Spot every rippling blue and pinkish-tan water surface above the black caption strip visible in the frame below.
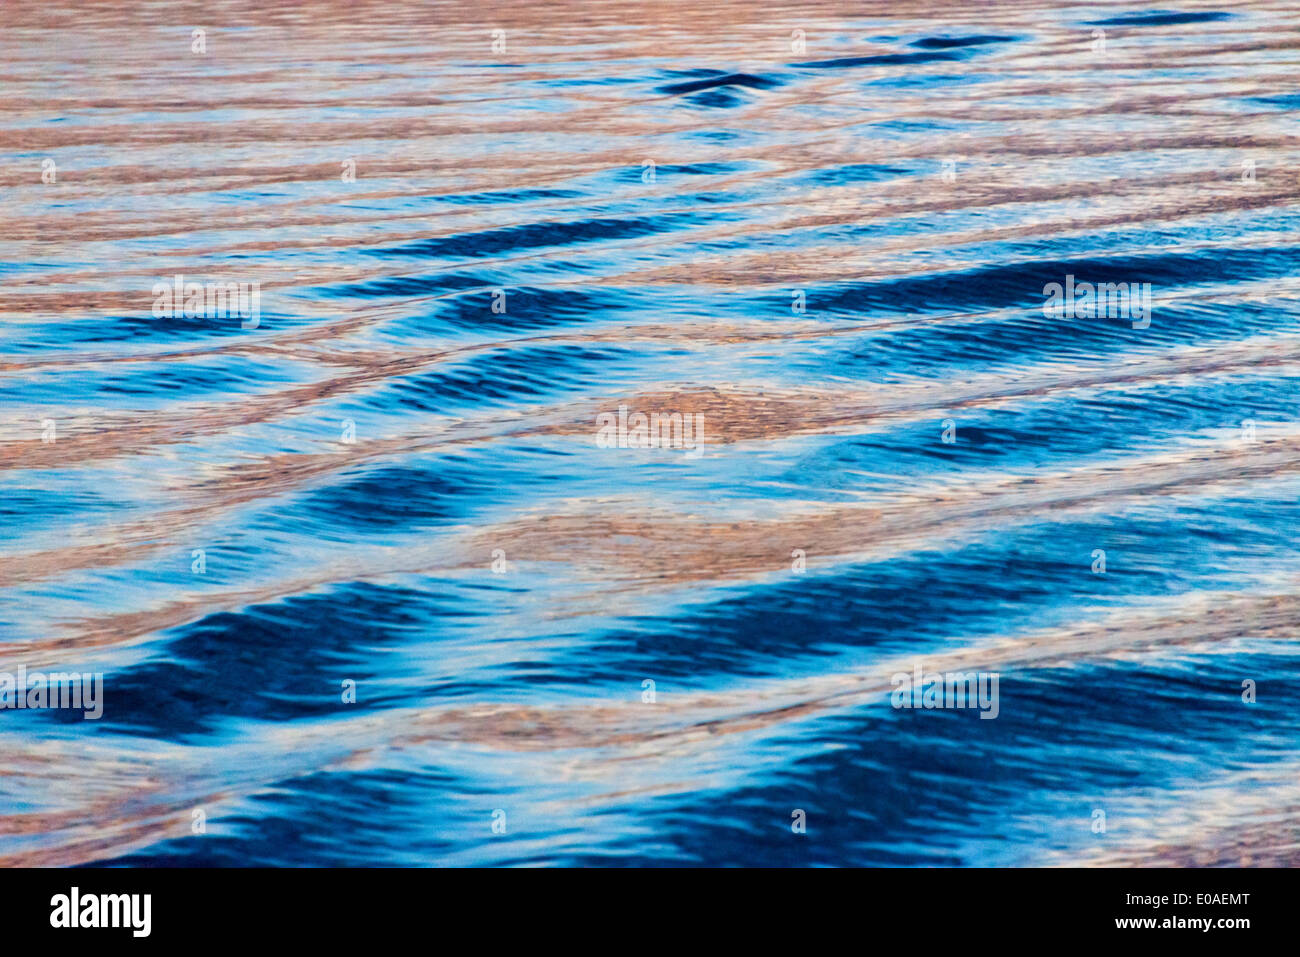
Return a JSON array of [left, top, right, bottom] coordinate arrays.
[[0, 0, 1300, 865]]
